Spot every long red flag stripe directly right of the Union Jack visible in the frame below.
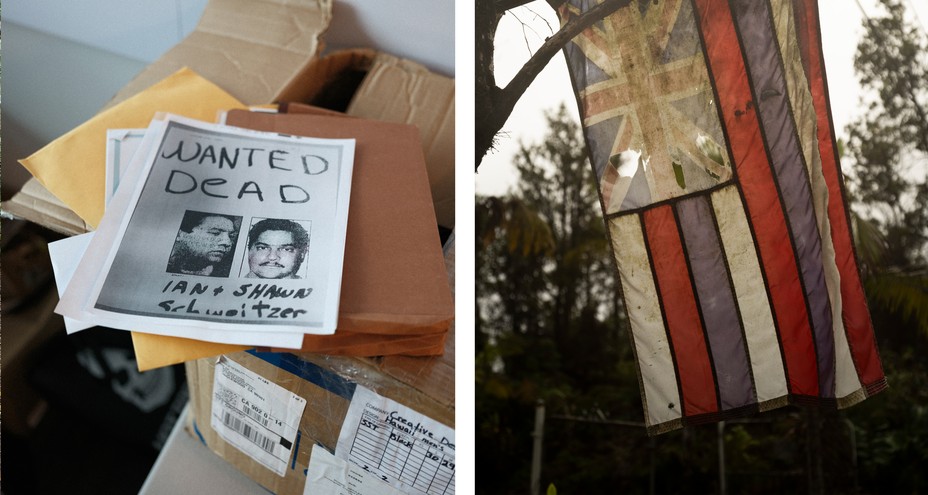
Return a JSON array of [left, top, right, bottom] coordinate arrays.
[[694, 0, 819, 396]]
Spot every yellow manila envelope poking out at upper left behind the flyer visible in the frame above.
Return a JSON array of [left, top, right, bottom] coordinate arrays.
[[19, 67, 245, 228]]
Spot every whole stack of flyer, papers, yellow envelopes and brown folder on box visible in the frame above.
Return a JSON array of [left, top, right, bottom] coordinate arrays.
[[23, 70, 453, 369]]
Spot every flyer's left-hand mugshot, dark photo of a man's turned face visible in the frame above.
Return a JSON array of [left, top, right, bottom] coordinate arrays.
[[166, 210, 242, 277]]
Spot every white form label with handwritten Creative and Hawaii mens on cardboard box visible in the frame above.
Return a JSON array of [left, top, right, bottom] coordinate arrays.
[[335, 386, 454, 495]]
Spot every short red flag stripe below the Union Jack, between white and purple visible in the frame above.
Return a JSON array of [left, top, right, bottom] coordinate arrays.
[[643, 205, 718, 416]]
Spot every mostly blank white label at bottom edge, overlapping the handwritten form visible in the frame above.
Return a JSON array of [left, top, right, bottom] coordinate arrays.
[[303, 444, 406, 495]]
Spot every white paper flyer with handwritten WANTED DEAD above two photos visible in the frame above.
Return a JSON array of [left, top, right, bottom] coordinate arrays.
[[57, 116, 354, 340]]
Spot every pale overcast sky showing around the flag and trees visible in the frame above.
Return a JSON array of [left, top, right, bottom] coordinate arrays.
[[475, 0, 928, 195]]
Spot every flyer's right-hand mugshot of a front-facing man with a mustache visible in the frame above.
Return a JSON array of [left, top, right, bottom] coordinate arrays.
[[240, 218, 312, 279]]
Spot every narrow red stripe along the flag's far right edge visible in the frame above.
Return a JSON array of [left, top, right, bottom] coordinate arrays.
[[800, 0, 884, 392]]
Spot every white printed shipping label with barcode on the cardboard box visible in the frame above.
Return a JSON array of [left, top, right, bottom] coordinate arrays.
[[210, 356, 306, 476]]
